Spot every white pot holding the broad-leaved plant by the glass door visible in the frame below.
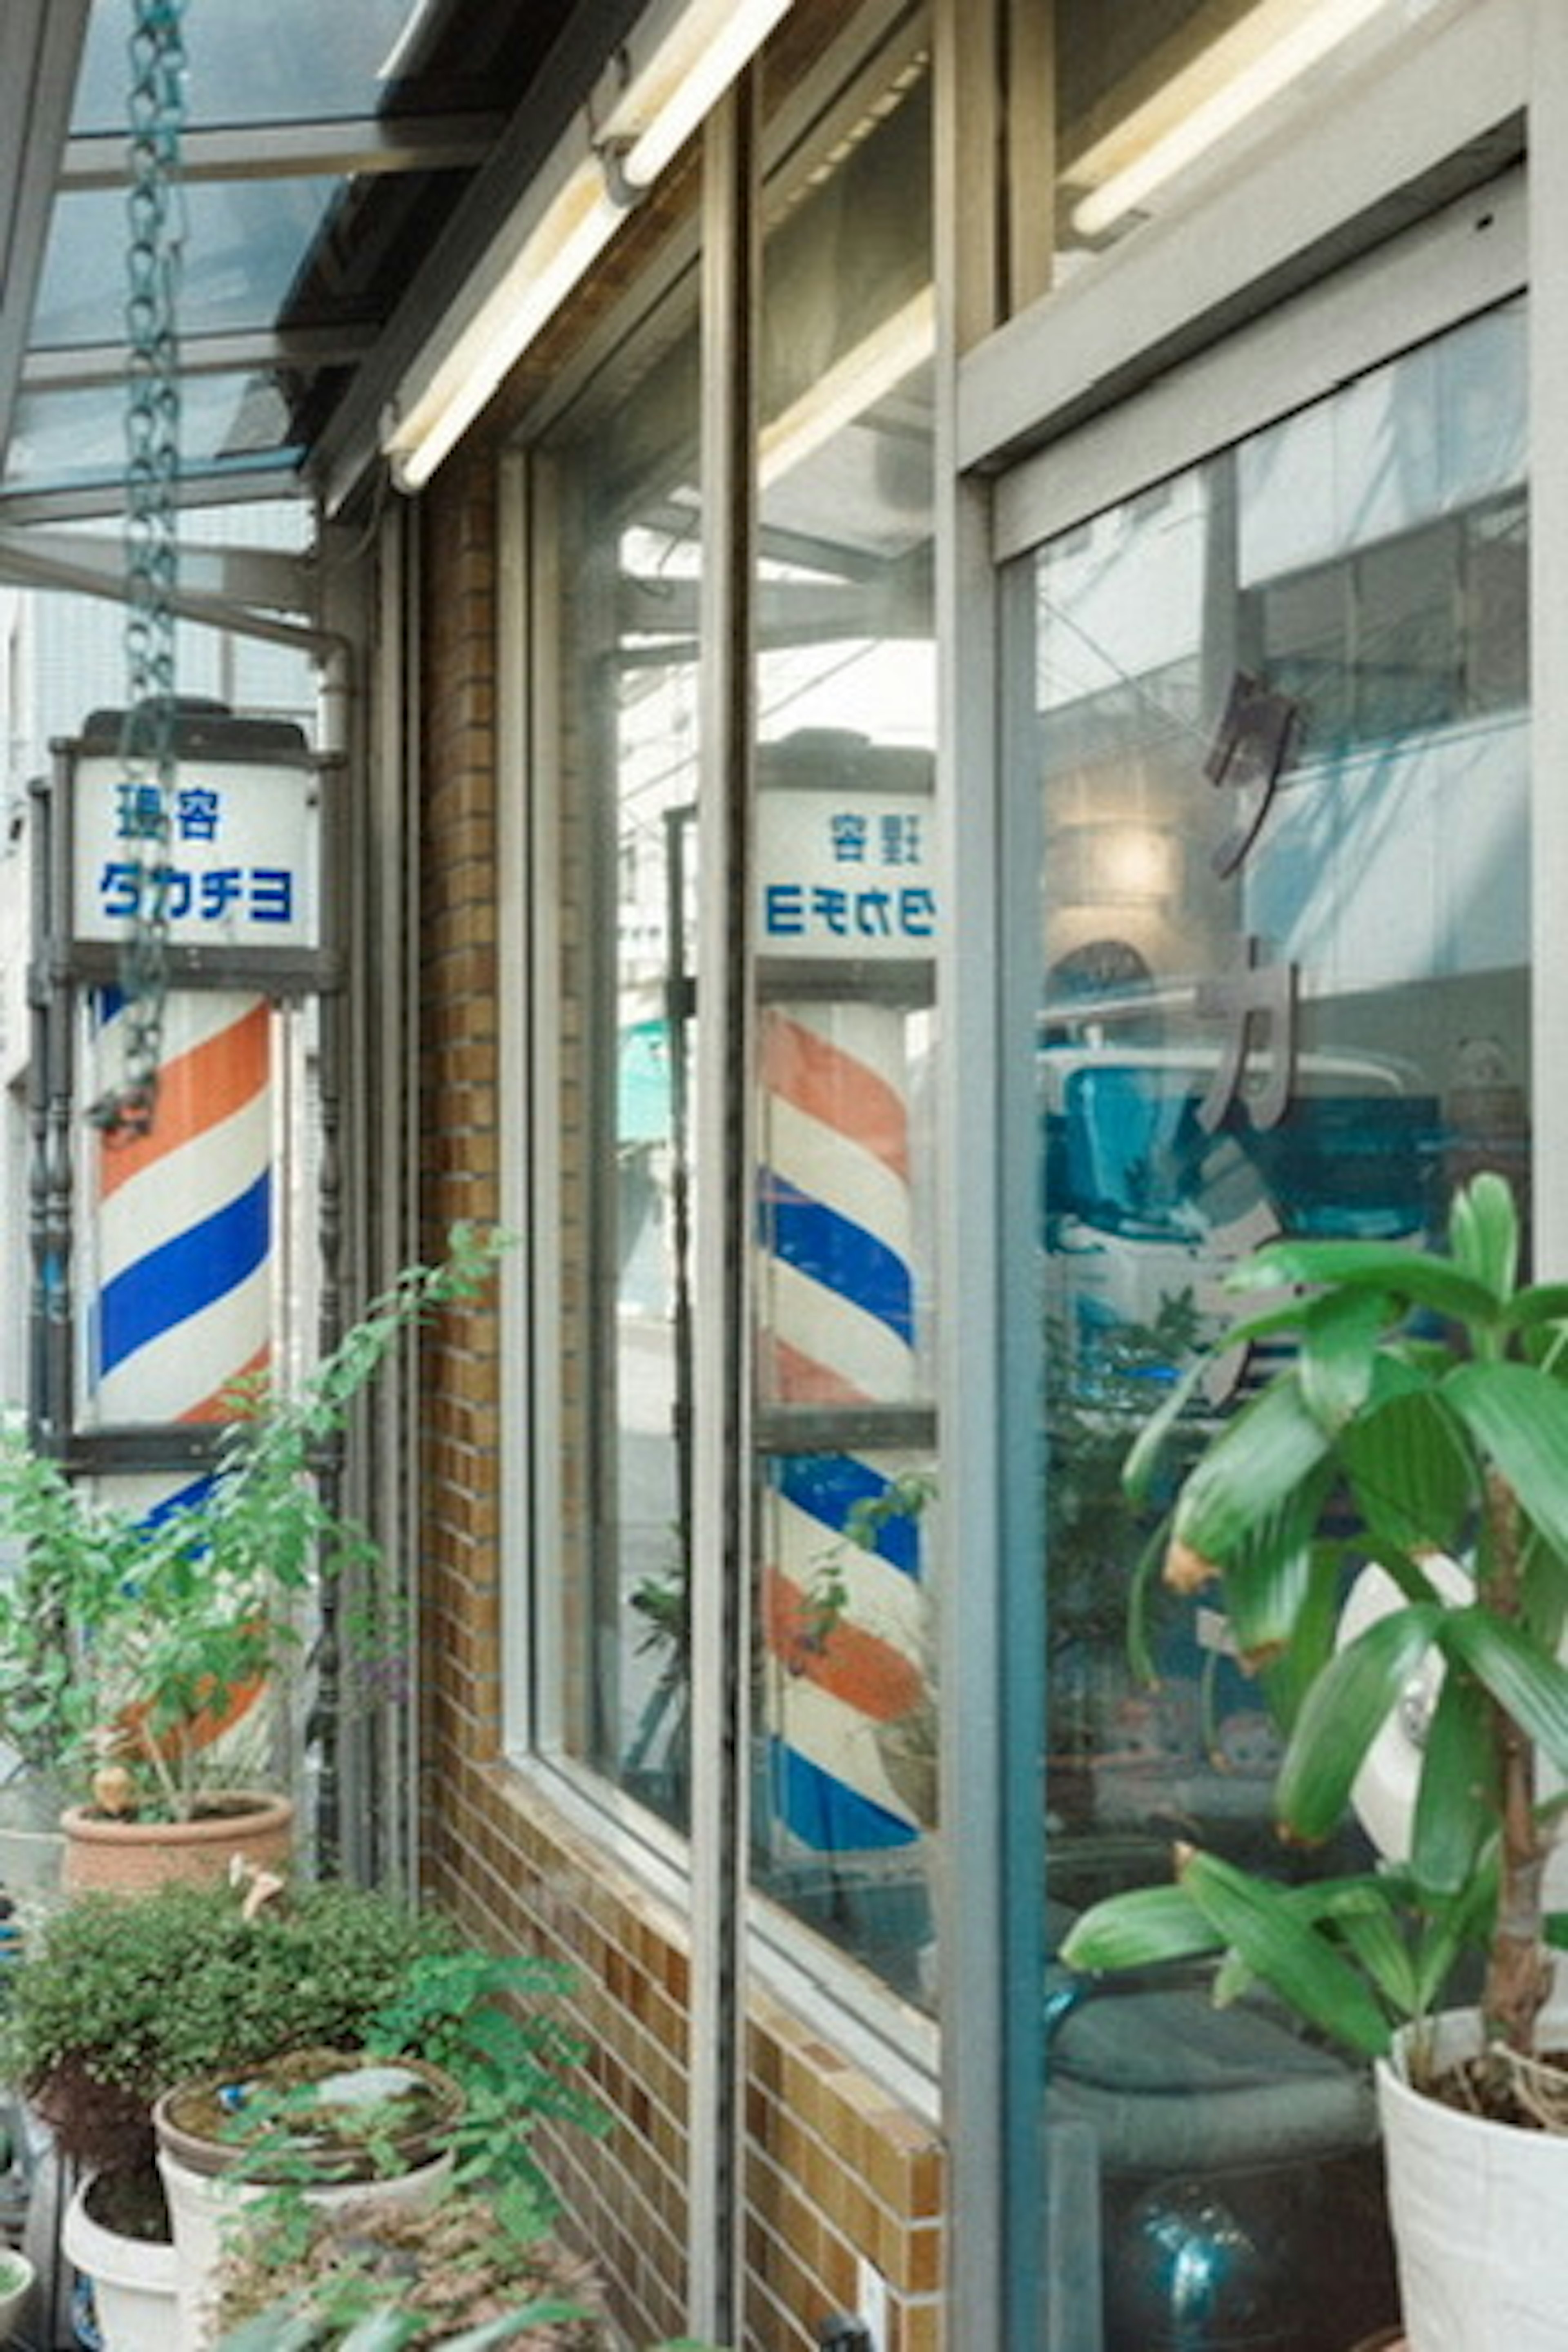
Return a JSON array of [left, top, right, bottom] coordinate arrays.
[[1378, 2011, 1568, 2352]]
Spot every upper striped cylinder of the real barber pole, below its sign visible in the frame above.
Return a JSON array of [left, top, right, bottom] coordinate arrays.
[[89, 990, 273, 1423]]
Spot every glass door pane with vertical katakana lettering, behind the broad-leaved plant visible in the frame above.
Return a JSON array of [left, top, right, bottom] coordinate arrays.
[[1013, 303, 1530, 2352]]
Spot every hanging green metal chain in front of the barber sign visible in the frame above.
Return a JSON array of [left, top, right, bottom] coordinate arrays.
[[89, 0, 186, 1136]]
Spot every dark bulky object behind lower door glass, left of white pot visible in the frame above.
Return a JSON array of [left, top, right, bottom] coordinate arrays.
[[1046, 1903, 1399, 2352]]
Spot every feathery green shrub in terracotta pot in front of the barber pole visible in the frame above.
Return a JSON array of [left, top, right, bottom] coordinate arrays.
[[0, 1225, 501, 1889]]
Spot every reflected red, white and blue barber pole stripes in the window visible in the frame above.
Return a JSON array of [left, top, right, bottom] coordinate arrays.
[[760, 1002, 922, 1851]]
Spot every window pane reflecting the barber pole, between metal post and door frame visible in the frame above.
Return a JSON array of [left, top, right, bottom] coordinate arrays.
[[752, 61, 940, 1997]]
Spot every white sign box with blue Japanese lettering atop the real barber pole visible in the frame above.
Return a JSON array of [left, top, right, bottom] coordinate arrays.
[[73, 757, 320, 948]]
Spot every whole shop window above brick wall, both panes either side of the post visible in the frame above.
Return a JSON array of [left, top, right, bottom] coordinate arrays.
[[536, 13, 940, 1997]]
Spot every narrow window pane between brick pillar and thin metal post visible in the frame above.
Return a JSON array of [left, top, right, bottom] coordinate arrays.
[[538, 275, 701, 1823]]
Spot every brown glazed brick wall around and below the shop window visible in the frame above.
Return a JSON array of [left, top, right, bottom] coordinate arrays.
[[421, 442, 943, 2352]]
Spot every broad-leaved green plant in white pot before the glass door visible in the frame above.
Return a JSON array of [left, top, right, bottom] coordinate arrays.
[[1062, 1174, 1568, 2352]]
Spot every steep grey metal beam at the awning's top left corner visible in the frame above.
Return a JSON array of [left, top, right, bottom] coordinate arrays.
[[0, 0, 89, 452]]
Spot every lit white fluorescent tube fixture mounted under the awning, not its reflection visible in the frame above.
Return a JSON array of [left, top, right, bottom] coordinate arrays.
[[381, 0, 792, 492]]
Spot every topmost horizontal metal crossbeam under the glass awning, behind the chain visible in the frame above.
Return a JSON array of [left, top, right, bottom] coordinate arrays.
[[59, 115, 506, 193]]
